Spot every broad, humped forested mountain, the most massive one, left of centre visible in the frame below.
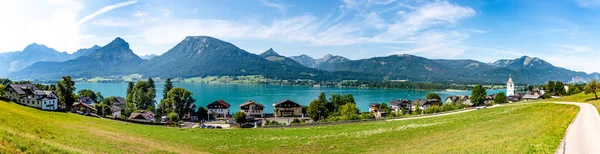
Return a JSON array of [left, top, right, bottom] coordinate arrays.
[[137, 36, 383, 80]]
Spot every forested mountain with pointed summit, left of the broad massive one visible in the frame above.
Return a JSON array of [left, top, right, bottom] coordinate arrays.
[[9, 37, 144, 80]]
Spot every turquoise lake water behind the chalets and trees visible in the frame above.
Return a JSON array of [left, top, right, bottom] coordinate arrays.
[[75, 83, 505, 113]]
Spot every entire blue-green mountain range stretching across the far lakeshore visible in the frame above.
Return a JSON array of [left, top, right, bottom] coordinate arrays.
[[3, 36, 599, 84]]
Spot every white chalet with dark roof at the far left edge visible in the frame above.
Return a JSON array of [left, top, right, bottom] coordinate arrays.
[[5, 84, 58, 110]]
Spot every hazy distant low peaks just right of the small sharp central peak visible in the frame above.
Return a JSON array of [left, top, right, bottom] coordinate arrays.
[[289, 54, 350, 70]]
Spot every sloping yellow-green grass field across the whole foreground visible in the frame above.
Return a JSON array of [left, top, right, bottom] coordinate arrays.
[[0, 101, 579, 153]]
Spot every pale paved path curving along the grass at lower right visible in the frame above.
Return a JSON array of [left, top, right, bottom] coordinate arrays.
[[556, 102, 600, 154]]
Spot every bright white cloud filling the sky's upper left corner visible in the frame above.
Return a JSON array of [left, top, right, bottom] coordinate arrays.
[[0, 0, 138, 52]]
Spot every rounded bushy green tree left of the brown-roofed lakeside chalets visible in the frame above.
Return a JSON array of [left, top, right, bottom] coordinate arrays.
[[163, 88, 196, 119]]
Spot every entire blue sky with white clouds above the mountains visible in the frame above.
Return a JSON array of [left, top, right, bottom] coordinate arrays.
[[0, 0, 600, 73]]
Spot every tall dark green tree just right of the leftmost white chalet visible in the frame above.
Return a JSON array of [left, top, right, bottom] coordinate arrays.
[[56, 76, 75, 109]]
